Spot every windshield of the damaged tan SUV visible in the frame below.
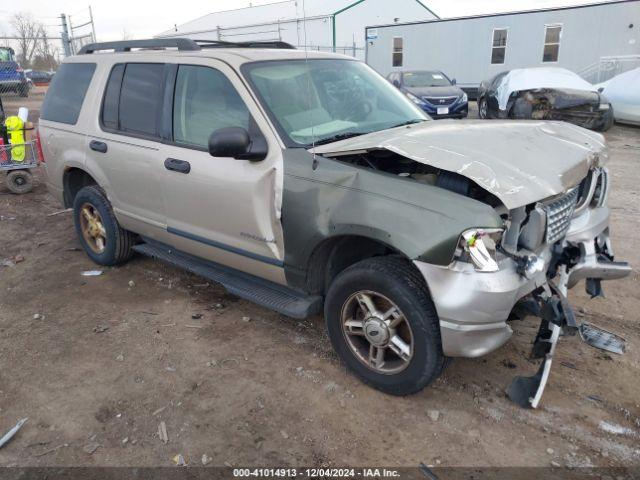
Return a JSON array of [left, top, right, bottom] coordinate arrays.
[[243, 59, 429, 147]]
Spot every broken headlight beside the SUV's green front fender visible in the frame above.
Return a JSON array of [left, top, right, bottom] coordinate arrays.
[[456, 228, 504, 272]]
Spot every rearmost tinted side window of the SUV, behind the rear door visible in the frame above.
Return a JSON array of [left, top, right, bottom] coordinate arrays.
[[40, 63, 96, 125]]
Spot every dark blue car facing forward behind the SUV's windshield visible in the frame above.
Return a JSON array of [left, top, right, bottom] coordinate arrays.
[[387, 70, 469, 119]]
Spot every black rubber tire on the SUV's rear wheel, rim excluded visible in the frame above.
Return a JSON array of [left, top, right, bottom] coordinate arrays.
[[73, 185, 136, 266]]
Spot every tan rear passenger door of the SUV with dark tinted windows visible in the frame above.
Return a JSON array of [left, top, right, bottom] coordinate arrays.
[[86, 62, 169, 239]]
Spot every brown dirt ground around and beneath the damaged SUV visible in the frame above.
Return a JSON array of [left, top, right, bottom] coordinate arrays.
[[0, 91, 640, 466]]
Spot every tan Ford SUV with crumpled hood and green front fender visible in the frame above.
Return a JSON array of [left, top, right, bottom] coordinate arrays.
[[39, 39, 629, 407]]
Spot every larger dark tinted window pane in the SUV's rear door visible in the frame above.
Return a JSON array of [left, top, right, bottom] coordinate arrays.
[[119, 63, 164, 137]]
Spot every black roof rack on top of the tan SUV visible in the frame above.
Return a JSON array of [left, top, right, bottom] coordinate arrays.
[[78, 38, 296, 55]]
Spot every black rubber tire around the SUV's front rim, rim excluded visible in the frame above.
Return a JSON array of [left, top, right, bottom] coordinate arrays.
[[325, 256, 445, 395]]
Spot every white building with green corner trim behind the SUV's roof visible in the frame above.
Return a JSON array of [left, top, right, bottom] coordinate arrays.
[[157, 0, 438, 59]]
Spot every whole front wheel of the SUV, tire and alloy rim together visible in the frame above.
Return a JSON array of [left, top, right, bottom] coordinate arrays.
[[325, 256, 445, 395]]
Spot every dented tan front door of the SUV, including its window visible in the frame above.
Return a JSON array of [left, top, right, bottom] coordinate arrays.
[[162, 59, 286, 284]]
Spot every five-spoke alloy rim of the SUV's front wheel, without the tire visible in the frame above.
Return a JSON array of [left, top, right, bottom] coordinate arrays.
[[340, 290, 414, 375]]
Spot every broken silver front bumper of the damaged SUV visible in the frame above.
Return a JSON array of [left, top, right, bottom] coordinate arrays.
[[414, 207, 631, 357]]
